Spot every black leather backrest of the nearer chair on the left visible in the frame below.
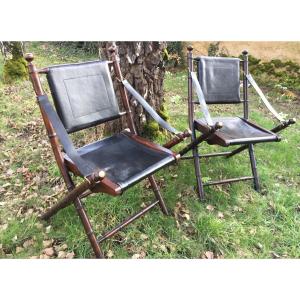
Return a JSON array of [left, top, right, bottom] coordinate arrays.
[[47, 61, 120, 132]]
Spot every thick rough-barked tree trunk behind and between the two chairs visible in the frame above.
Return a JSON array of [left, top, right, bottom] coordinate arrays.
[[100, 42, 167, 135]]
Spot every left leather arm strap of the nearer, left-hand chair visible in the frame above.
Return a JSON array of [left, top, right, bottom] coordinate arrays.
[[37, 95, 99, 177]]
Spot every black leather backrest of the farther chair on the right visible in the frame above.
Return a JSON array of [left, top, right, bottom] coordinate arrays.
[[196, 56, 241, 104]]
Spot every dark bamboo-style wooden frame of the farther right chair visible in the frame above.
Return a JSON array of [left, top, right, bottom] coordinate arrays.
[[182, 46, 296, 200]]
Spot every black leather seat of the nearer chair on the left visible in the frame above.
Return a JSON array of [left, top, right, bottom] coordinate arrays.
[[65, 132, 176, 190]]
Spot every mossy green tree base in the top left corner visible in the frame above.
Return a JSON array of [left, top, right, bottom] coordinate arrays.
[[1, 42, 27, 82]]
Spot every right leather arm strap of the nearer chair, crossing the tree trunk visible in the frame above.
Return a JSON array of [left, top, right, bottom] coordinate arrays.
[[122, 80, 179, 134]]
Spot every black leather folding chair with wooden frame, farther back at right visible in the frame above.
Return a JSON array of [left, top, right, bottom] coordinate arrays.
[[185, 47, 295, 200]]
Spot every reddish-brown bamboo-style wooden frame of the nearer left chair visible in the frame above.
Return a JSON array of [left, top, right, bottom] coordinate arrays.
[[25, 47, 190, 258]]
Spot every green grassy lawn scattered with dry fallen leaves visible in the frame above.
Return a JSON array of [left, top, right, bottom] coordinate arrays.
[[0, 43, 300, 258]]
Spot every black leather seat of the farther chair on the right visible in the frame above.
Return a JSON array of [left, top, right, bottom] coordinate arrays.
[[194, 117, 280, 147]]
